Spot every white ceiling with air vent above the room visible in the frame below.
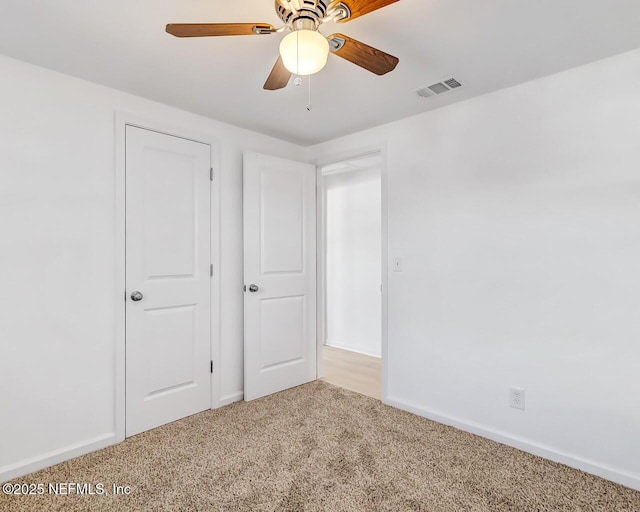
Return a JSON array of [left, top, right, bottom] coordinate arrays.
[[0, 0, 640, 145]]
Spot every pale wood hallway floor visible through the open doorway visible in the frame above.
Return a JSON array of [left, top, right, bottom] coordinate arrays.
[[321, 345, 382, 400]]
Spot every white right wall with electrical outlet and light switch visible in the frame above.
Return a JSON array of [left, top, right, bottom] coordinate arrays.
[[308, 50, 640, 489]]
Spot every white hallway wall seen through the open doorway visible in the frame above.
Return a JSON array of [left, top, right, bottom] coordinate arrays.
[[323, 167, 382, 357]]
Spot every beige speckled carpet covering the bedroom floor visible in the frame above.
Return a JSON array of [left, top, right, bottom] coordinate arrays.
[[0, 382, 640, 512]]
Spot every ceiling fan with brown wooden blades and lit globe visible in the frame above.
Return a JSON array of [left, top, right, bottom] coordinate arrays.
[[167, 0, 399, 91]]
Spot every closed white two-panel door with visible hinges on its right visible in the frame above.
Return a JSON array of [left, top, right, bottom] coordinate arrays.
[[125, 126, 211, 436]]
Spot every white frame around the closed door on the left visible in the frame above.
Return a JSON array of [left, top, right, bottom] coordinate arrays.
[[114, 111, 220, 443]]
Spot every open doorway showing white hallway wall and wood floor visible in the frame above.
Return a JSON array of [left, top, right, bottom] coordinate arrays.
[[318, 152, 383, 399]]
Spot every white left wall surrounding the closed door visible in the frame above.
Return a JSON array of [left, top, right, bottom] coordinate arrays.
[[0, 57, 303, 480]]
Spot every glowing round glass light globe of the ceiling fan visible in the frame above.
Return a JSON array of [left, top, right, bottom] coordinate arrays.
[[280, 30, 329, 75]]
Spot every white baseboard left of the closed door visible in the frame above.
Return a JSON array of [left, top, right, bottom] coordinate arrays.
[[0, 432, 119, 482]]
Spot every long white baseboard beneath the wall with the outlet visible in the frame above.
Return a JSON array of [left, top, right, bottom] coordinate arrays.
[[385, 397, 640, 491]]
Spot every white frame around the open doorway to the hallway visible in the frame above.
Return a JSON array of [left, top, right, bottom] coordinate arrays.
[[313, 143, 389, 403]]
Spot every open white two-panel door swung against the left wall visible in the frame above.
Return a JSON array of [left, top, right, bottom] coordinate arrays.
[[244, 152, 316, 400]]
